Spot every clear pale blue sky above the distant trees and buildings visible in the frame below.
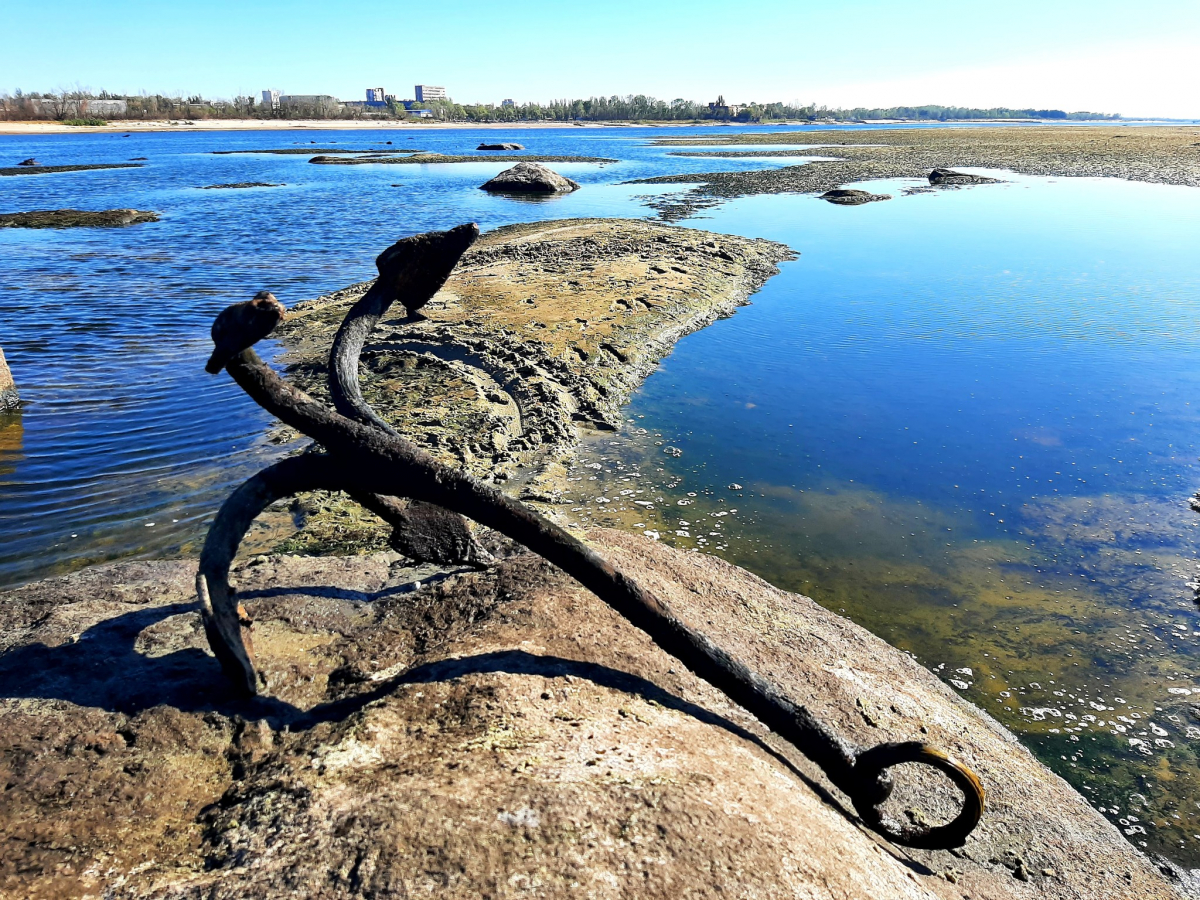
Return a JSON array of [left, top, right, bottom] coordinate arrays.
[[0, 0, 1200, 116]]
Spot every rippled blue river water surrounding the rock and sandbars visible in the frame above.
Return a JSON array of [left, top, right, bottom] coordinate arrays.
[[0, 128, 1200, 865]]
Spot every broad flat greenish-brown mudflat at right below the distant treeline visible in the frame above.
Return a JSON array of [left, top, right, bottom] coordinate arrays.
[[634, 125, 1200, 220]]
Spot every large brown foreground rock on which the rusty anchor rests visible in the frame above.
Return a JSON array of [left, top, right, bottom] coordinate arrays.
[[0, 532, 1177, 900]]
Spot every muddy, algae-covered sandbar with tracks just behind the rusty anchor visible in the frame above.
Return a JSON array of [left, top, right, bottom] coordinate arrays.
[[276, 220, 794, 552]]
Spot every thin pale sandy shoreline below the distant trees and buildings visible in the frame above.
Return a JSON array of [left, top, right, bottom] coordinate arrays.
[[0, 119, 1188, 134]]
